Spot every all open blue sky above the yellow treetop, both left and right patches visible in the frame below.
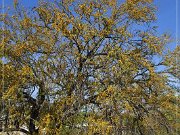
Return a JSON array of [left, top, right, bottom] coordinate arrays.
[[0, 0, 180, 50]]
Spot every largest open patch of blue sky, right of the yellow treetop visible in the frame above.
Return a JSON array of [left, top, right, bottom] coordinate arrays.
[[154, 0, 180, 50]]
